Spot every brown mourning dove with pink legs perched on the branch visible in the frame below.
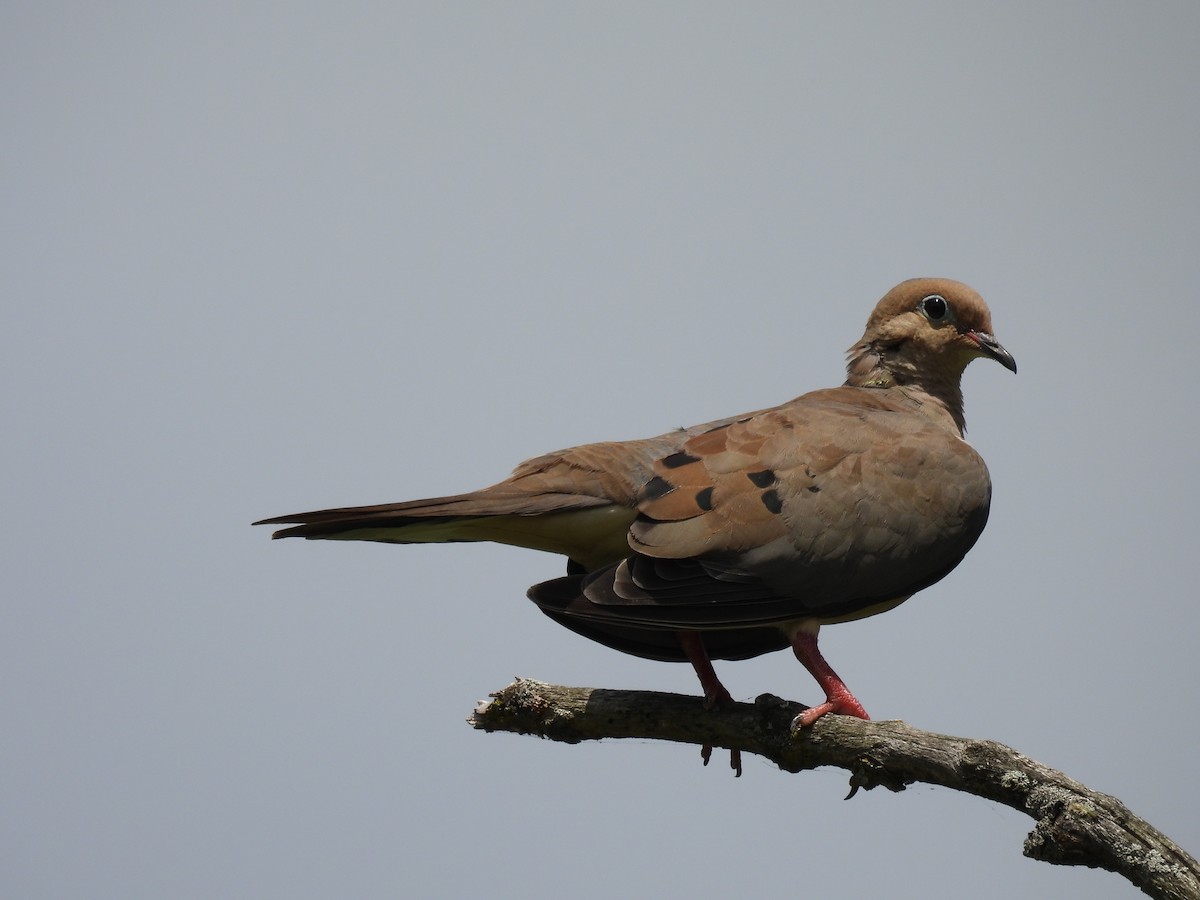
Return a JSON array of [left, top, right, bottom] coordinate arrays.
[[256, 278, 1016, 758]]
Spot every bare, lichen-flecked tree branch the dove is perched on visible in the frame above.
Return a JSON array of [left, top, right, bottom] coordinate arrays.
[[468, 678, 1200, 900]]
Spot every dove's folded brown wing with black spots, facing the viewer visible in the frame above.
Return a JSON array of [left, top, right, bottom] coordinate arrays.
[[534, 388, 991, 629]]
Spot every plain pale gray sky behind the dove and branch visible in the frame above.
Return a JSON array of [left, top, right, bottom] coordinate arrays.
[[0, 2, 1200, 900]]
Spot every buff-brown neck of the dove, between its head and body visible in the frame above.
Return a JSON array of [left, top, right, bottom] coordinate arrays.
[[846, 342, 967, 436]]
